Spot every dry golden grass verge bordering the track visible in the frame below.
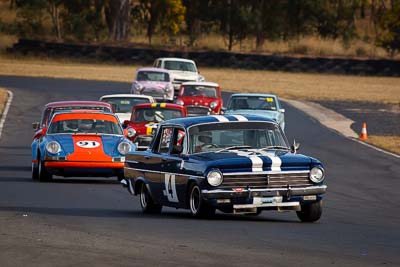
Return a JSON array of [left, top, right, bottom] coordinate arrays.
[[0, 55, 400, 155]]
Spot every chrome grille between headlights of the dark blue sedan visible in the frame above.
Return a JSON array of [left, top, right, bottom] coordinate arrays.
[[219, 172, 313, 189]]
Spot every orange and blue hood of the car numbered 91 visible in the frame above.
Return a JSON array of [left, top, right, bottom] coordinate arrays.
[[46, 134, 125, 156]]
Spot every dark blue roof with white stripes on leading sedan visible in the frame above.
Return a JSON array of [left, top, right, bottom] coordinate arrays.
[[161, 114, 276, 128]]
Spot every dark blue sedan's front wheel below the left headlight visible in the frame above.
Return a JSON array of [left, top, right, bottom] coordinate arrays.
[[188, 184, 215, 218]]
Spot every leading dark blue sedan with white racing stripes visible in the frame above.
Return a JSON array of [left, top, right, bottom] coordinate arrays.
[[121, 115, 327, 222]]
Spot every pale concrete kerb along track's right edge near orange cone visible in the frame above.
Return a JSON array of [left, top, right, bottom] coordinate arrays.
[[281, 98, 400, 158]]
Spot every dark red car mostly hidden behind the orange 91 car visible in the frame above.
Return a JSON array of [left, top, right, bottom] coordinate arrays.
[[32, 101, 113, 139]]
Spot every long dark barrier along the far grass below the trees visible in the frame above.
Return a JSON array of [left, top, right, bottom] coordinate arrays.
[[8, 39, 400, 77]]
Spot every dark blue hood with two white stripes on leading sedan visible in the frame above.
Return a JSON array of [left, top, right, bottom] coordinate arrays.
[[191, 149, 319, 173]]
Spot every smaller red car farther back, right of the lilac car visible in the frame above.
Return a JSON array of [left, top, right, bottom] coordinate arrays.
[[175, 82, 223, 116]]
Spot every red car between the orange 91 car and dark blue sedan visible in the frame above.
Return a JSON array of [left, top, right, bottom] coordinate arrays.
[[123, 103, 187, 150]]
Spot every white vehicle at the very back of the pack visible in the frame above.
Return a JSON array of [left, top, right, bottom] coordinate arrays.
[[153, 57, 205, 96]]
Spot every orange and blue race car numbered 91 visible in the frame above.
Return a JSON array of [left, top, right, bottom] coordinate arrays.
[[32, 110, 135, 181]]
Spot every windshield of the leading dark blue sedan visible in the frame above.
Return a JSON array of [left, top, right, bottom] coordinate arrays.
[[189, 122, 288, 154]]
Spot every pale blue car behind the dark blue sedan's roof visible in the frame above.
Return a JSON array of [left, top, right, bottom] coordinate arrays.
[[225, 94, 285, 130]]
